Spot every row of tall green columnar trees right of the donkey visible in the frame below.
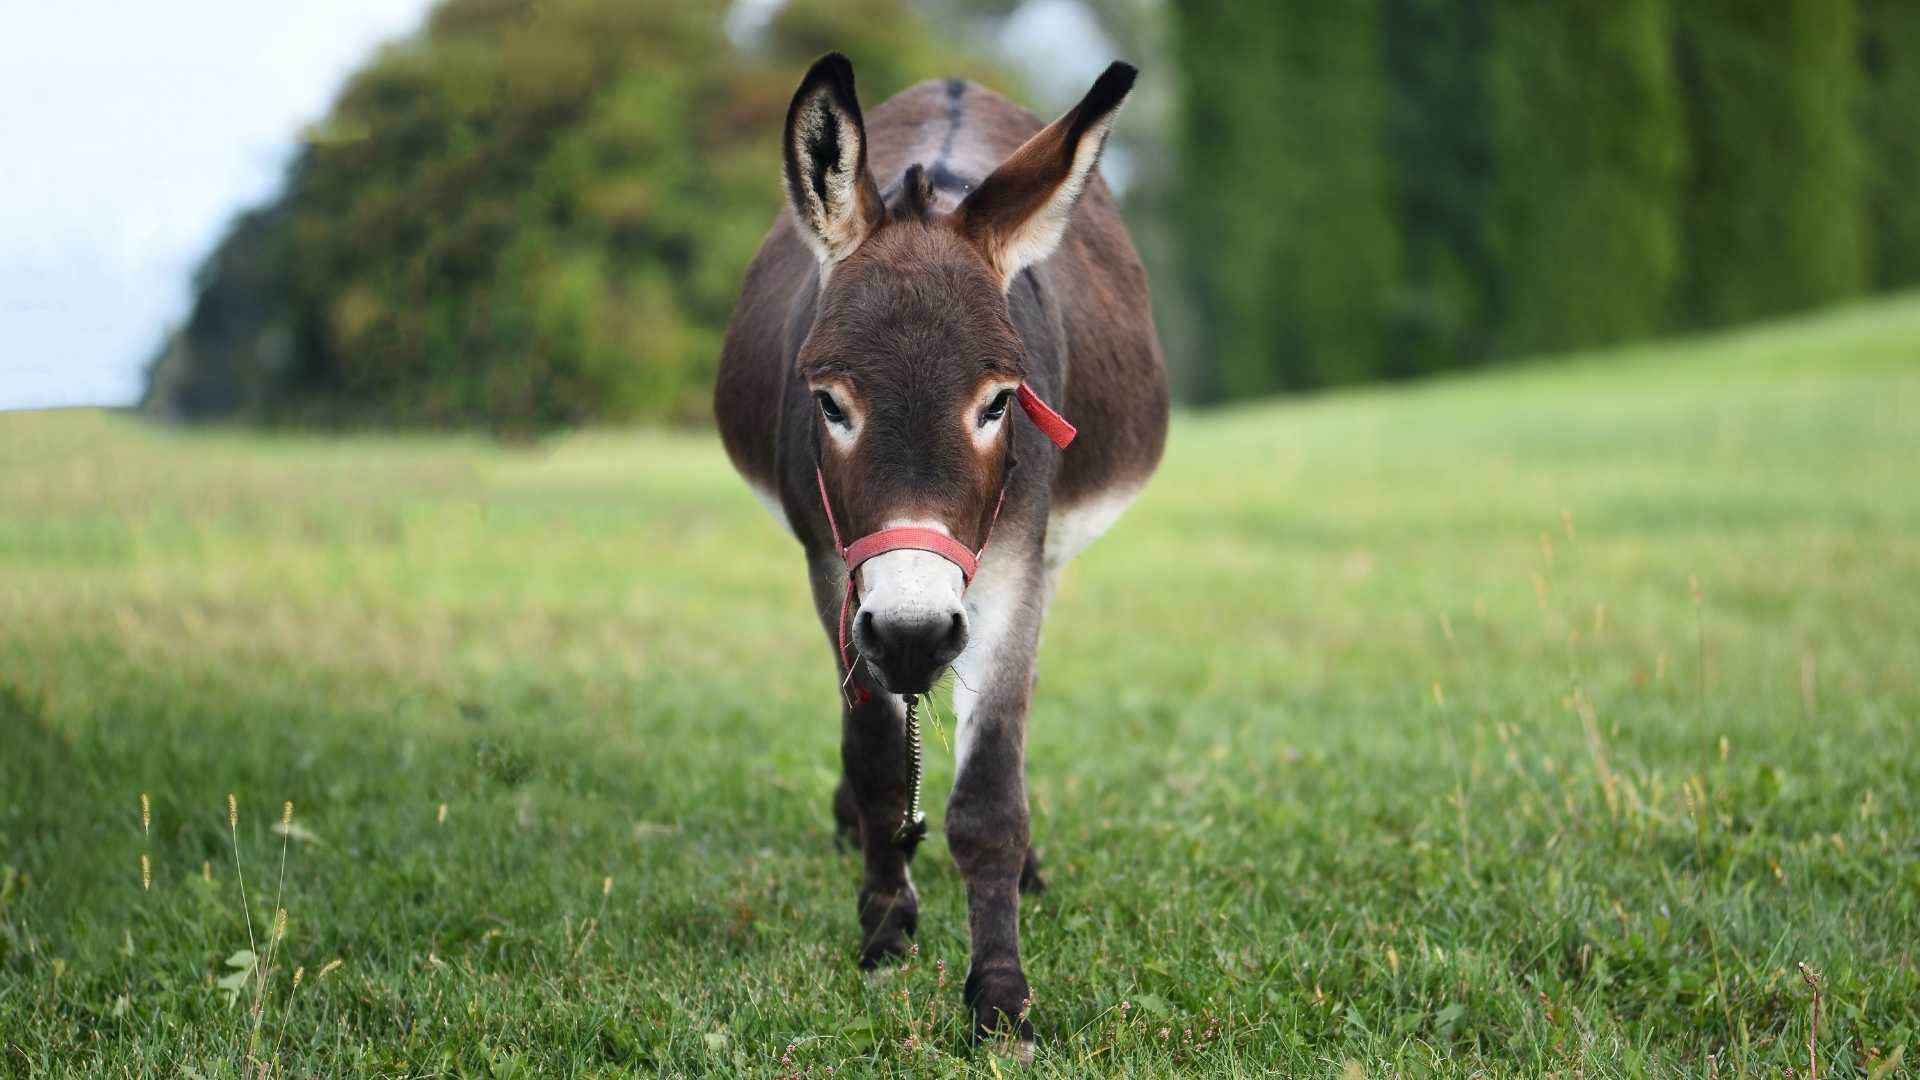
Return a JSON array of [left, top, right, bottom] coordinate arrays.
[[1173, 0, 1920, 398]]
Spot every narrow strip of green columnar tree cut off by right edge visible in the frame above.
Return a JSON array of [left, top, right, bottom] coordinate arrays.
[[1860, 0, 1920, 288]]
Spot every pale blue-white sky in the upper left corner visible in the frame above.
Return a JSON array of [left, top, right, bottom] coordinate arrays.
[[0, 0, 428, 409]]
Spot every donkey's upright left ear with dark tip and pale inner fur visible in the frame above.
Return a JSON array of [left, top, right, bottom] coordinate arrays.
[[781, 52, 887, 265]]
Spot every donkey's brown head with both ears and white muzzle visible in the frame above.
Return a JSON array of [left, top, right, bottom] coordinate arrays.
[[783, 54, 1135, 694]]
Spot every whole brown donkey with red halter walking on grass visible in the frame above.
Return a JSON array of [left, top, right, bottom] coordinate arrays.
[[714, 54, 1167, 1051]]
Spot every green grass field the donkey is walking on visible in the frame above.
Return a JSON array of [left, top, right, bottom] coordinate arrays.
[[0, 298, 1920, 1076]]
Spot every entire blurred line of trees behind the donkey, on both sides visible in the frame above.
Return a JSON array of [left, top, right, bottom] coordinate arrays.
[[148, 0, 1920, 430]]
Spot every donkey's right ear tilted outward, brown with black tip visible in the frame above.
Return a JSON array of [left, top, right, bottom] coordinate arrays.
[[958, 61, 1139, 288]]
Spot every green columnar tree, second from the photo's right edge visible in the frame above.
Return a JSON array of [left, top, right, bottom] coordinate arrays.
[[1674, 0, 1858, 325]]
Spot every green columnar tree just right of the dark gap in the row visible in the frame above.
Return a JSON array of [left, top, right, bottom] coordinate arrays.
[[1486, 0, 1684, 354]]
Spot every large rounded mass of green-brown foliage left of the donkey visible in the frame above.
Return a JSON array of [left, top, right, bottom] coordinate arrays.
[[152, 0, 990, 429]]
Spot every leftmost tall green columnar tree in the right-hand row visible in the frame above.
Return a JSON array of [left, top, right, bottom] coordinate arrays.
[[1175, 0, 1400, 398]]
